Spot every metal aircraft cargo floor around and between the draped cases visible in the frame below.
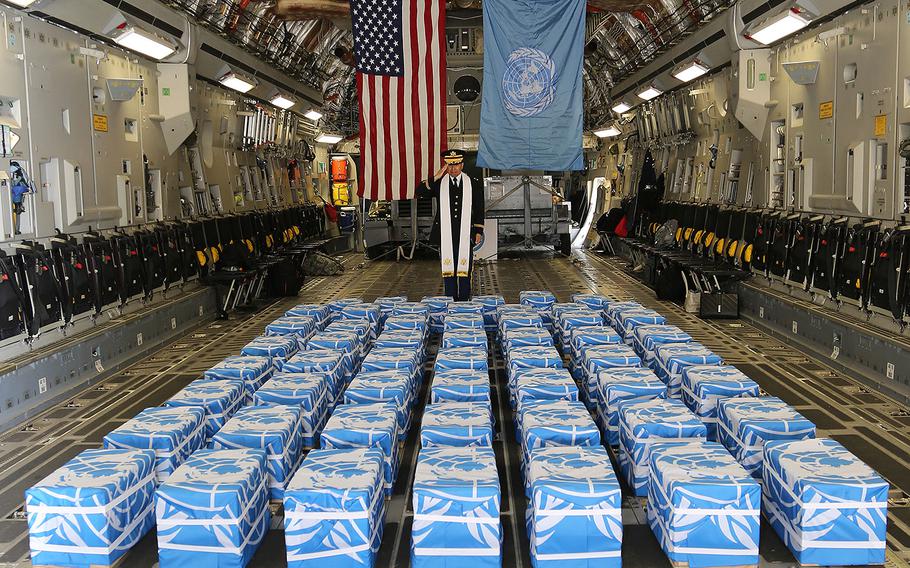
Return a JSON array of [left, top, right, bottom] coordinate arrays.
[[0, 255, 910, 568]]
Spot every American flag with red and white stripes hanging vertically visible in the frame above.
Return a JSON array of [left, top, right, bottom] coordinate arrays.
[[351, 0, 446, 200]]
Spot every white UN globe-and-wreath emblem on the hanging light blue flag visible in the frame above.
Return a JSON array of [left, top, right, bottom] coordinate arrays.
[[502, 47, 556, 116]]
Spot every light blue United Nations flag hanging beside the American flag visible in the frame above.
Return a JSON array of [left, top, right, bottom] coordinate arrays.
[[477, 0, 585, 170]]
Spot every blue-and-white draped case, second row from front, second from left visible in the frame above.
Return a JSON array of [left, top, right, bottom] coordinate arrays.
[[211, 406, 303, 499]]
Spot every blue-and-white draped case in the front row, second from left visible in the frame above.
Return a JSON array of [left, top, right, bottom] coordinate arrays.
[[155, 450, 271, 568]]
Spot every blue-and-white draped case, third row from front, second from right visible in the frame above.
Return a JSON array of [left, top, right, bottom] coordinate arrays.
[[597, 367, 667, 446]]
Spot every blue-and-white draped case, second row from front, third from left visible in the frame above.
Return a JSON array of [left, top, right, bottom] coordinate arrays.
[[321, 404, 398, 494]]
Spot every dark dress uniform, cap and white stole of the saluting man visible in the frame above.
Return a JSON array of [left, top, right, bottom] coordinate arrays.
[[417, 150, 484, 301]]
